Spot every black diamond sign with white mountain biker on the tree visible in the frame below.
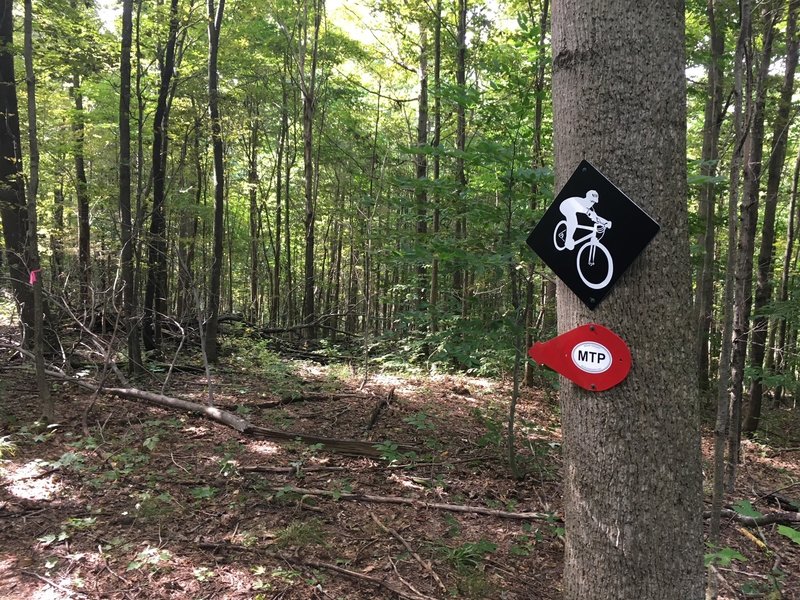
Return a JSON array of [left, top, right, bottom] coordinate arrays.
[[528, 160, 659, 310]]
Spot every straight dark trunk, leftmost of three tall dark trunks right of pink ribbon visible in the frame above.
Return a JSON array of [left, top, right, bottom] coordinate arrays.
[[119, 0, 142, 374]]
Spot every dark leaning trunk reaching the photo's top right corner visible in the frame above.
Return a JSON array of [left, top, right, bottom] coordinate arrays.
[[742, 0, 800, 433]]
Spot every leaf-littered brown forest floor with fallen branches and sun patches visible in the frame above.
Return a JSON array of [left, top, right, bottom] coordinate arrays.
[[0, 330, 800, 600]]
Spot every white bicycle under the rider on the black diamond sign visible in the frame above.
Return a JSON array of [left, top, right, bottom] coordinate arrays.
[[553, 217, 614, 290]]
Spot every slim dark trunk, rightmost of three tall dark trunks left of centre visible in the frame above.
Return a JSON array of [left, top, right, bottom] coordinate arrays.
[[205, 0, 225, 363]]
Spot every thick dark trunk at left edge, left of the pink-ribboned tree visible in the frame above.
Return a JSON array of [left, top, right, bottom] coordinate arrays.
[[0, 0, 35, 338]]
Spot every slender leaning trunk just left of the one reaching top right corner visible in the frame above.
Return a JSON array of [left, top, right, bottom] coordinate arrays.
[[728, 7, 777, 478]]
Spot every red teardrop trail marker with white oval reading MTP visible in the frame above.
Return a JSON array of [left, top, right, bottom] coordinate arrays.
[[528, 323, 631, 392]]
